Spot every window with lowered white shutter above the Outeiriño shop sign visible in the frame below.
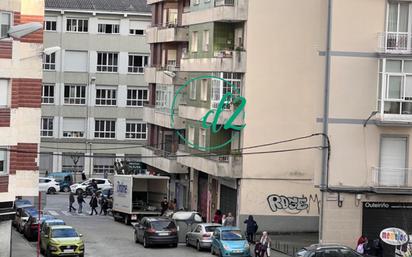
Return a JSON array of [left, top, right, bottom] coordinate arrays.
[[376, 136, 408, 187]]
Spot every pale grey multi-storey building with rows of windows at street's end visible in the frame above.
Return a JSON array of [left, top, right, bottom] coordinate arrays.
[[40, 0, 151, 177]]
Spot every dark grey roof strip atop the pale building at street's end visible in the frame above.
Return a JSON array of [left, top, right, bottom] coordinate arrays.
[[46, 0, 151, 13]]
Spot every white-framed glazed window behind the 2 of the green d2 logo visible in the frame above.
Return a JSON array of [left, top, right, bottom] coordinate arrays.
[[211, 72, 242, 109]]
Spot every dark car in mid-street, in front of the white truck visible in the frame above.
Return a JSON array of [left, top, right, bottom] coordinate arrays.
[[133, 217, 179, 248]]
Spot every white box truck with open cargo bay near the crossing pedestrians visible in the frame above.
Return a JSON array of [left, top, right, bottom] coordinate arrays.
[[112, 175, 169, 224]]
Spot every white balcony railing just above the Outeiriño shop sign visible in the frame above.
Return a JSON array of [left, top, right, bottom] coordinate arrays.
[[372, 167, 412, 188]]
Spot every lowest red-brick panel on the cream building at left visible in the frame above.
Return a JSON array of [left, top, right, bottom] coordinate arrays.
[[9, 143, 39, 174]]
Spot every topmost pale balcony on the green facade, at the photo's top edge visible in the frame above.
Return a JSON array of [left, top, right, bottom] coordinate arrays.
[[182, 0, 248, 26]]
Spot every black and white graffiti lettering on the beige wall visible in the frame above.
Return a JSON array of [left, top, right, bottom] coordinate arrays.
[[267, 194, 320, 214]]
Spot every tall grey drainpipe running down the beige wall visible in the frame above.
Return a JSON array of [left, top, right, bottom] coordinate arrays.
[[319, 0, 333, 243]]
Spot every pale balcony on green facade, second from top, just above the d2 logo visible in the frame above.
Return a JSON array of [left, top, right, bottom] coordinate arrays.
[[180, 50, 246, 73]]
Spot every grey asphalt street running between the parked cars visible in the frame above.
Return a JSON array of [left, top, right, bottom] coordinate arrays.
[[12, 193, 285, 257]]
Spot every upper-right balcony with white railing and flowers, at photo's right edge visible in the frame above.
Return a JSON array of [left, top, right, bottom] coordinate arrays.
[[378, 32, 412, 54]]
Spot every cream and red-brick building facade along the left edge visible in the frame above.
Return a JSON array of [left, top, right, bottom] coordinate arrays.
[[0, 0, 44, 254]]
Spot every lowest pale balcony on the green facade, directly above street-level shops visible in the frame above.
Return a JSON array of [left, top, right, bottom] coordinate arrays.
[[177, 145, 242, 178]]
